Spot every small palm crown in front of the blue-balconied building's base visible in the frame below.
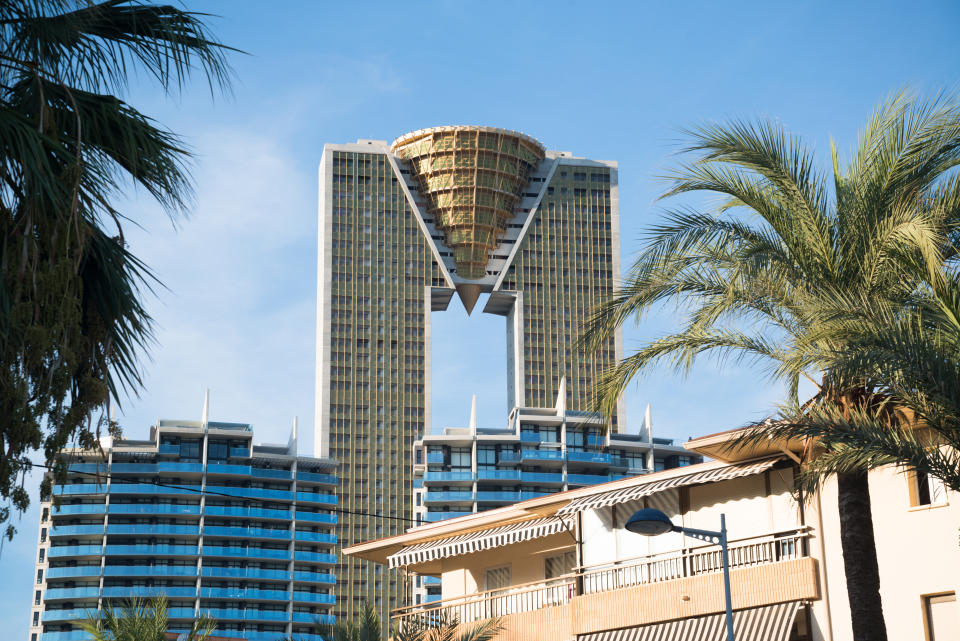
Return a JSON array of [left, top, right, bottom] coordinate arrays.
[[80, 596, 217, 641]]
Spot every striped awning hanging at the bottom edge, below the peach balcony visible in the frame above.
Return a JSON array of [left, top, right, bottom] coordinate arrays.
[[577, 601, 800, 641]]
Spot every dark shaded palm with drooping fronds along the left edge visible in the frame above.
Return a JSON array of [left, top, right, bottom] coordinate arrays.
[[0, 0, 229, 536]]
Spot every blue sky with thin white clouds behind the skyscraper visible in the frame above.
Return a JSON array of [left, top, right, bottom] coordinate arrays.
[[7, 0, 960, 639]]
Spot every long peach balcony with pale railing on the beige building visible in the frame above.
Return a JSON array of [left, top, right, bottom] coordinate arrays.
[[392, 529, 819, 641]]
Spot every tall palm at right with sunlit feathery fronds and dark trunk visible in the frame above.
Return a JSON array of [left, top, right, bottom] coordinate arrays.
[[581, 92, 960, 641]]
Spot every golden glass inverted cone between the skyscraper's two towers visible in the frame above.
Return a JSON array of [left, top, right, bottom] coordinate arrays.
[[391, 126, 545, 308]]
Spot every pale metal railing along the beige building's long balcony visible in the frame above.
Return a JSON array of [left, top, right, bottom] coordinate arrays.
[[393, 528, 809, 629]]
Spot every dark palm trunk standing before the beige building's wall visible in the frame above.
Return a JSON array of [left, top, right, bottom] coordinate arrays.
[[837, 472, 887, 641]]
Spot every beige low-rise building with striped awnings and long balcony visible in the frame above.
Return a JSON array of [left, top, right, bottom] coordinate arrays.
[[344, 424, 960, 641]]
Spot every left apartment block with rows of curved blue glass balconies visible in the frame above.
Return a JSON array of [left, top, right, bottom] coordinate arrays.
[[30, 420, 337, 641]]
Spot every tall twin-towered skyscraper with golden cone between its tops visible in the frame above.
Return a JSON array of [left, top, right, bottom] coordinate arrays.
[[315, 127, 623, 618]]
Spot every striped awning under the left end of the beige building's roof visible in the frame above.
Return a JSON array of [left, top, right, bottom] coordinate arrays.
[[387, 516, 567, 568]]
